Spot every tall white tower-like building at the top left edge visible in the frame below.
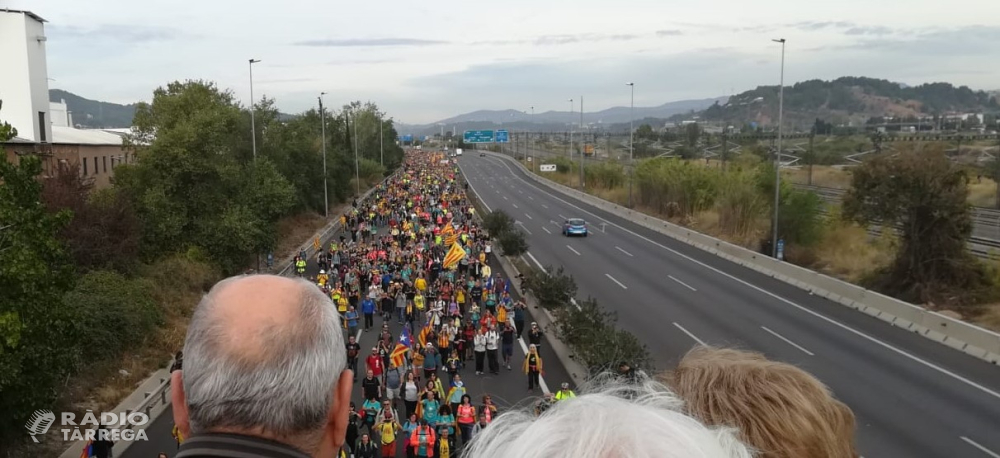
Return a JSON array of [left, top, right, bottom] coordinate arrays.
[[0, 9, 52, 143]]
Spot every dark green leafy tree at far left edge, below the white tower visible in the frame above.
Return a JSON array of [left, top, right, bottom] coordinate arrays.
[[0, 154, 76, 443]]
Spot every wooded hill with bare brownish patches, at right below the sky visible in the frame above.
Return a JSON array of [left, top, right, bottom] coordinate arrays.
[[696, 77, 1000, 129]]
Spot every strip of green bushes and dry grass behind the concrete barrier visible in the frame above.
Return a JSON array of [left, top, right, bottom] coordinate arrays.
[[535, 143, 1000, 330]]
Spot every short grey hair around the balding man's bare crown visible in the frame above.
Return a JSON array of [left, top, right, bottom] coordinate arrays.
[[183, 277, 347, 451]]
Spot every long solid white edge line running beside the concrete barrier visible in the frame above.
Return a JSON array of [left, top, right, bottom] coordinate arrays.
[[486, 156, 1000, 399]]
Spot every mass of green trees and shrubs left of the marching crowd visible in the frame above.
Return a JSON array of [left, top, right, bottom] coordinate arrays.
[[0, 81, 403, 457]]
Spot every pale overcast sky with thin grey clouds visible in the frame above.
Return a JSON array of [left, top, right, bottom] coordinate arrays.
[[0, 0, 1000, 124]]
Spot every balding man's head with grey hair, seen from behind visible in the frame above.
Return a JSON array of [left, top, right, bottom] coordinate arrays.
[[175, 275, 350, 454]]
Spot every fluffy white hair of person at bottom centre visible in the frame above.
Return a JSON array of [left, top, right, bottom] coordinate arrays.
[[463, 377, 753, 458]]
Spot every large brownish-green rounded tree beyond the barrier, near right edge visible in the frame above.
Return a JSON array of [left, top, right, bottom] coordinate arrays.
[[843, 150, 996, 305]]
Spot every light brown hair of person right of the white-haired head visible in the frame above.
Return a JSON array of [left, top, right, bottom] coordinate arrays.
[[662, 347, 858, 458]]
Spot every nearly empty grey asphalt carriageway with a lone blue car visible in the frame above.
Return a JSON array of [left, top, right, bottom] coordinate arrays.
[[459, 151, 1000, 458]]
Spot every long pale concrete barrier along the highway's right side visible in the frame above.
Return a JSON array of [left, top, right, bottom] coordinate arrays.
[[488, 153, 1000, 364]]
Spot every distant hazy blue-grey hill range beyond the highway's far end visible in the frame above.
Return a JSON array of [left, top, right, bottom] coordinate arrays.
[[399, 97, 728, 135]]
